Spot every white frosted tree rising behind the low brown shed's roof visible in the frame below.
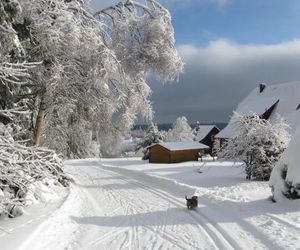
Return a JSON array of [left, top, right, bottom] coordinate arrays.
[[166, 116, 194, 142]]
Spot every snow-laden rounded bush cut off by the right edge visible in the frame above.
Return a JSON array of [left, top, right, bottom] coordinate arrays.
[[269, 126, 300, 201]]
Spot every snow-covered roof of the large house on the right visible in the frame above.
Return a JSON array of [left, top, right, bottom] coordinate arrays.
[[217, 81, 300, 138]]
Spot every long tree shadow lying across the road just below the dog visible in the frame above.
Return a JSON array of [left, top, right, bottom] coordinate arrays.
[[71, 204, 286, 249]]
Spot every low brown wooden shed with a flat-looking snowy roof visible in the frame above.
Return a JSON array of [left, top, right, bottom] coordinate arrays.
[[148, 142, 209, 163]]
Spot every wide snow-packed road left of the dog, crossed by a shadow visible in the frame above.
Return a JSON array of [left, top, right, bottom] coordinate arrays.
[[14, 161, 292, 250]]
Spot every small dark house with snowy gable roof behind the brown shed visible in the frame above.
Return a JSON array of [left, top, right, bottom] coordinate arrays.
[[195, 125, 220, 155]]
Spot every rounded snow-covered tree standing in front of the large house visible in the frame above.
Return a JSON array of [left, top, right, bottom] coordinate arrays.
[[218, 113, 289, 181]]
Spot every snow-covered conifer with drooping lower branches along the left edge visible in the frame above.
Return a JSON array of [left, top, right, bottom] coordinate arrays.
[[0, 0, 67, 217]]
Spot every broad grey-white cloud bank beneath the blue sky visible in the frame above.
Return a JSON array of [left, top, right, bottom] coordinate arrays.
[[153, 39, 300, 122]]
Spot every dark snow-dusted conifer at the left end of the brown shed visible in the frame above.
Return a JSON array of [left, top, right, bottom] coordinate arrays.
[[137, 123, 165, 160]]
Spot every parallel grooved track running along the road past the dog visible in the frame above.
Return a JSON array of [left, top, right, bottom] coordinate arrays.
[[98, 165, 241, 249]]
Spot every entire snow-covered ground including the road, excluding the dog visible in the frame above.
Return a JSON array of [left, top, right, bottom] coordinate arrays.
[[0, 159, 300, 250]]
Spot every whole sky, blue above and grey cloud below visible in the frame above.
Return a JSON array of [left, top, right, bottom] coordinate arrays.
[[91, 0, 300, 123]]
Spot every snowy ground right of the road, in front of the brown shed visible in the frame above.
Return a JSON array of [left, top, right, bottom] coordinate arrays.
[[102, 159, 300, 249]]
